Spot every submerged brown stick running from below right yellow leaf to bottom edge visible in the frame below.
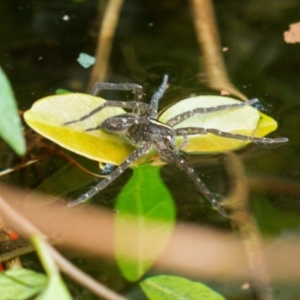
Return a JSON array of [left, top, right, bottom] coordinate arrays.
[[224, 153, 273, 300]]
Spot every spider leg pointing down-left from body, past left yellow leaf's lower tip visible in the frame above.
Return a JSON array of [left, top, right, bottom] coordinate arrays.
[[68, 144, 151, 207]]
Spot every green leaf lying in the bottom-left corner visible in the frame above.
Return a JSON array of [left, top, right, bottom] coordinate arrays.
[[0, 269, 48, 300]]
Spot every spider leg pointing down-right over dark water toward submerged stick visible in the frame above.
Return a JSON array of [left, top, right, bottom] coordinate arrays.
[[160, 149, 227, 217]]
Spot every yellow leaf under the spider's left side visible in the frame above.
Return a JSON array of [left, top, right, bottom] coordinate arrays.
[[24, 94, 134, 165]]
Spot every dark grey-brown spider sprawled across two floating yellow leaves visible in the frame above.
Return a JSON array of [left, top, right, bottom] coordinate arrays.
[[63, 75, 288, 217]]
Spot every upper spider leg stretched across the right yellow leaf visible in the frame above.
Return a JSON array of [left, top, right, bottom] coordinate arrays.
[[166, 98, 258, 127]]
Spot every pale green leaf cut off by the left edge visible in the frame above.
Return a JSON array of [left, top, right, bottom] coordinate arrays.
[[0, 67, 26, 155]]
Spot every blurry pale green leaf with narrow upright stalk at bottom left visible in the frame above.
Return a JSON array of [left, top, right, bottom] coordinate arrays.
[[31, 235, 72, 300]]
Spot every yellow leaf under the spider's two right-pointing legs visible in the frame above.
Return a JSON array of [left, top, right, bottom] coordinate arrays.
[[159, 96, 277, 154]]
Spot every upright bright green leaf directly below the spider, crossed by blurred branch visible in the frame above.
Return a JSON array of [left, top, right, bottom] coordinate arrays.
[[115, 164, 175, 281]]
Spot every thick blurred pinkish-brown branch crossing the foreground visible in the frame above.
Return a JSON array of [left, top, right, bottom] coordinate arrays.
[[4, 186, 300, 282]]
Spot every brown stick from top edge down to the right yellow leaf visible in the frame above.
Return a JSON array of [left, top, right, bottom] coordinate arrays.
[[190, 0, 247, 100]]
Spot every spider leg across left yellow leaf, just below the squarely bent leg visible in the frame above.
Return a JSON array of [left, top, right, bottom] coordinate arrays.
[[63, 101, 151, 125]]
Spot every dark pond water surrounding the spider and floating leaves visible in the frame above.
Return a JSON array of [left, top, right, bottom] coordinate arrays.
[[0, 0, 300, 299]]
